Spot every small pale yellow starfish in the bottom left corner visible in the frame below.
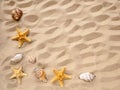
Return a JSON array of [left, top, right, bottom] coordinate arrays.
[[10, 67, 27, 84]]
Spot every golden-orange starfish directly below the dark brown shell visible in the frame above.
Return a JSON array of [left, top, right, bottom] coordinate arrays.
[[12, 28, 31, 48]]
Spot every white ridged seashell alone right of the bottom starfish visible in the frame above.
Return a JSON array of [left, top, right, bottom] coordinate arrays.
[[79, 72, 95, 81]]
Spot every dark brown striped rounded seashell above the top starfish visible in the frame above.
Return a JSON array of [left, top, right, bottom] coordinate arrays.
[[11, 8, 23, 21]]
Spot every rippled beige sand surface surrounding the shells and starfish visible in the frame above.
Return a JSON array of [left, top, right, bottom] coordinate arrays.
[[0, 0, 120, 90]]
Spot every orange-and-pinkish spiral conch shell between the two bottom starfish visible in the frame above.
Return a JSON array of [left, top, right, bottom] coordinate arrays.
[[34, 67, 47, 82]]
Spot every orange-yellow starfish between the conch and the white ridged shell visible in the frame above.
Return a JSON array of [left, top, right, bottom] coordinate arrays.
[[51, 68, 71, 87]]
